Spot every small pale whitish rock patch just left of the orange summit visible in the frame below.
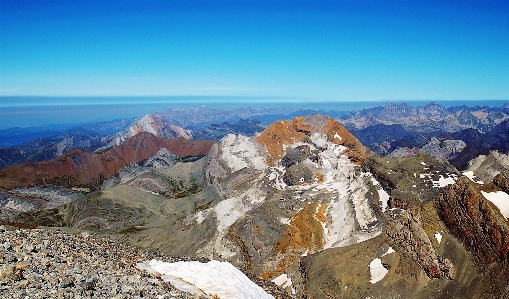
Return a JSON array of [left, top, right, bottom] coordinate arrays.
[[221, 134, 267, 172]]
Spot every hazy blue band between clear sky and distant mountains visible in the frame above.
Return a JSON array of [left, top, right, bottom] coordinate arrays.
[[0, 96, 509, 129]]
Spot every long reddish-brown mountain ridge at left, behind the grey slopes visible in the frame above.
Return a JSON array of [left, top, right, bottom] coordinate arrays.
[[0, 132, 214, 190]]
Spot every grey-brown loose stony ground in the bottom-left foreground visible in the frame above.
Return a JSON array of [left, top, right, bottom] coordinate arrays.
[[0, 226, 282, 299]]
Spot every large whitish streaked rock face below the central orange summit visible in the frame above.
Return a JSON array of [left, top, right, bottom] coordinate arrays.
[[291, 133, 380, 249]]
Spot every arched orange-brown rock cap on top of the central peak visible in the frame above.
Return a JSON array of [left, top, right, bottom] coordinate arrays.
[[256, 115, 370, 165]]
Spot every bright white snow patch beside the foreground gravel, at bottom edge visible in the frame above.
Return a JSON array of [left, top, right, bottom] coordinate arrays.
[[136, 260, 274, 299]]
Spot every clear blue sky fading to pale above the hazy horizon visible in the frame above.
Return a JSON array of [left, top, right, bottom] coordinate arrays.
[[0, 0, 509, 101]]
